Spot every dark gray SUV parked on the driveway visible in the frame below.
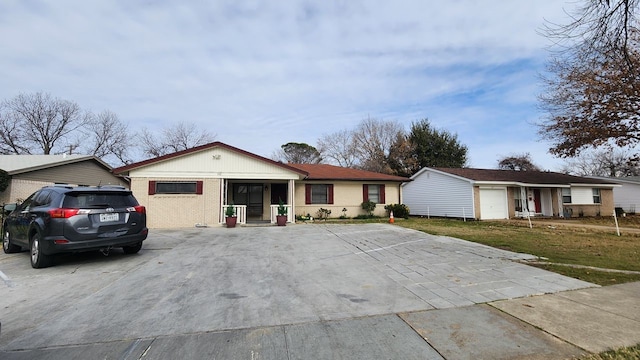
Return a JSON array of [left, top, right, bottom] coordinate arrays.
[[2, 185, 149, 268]]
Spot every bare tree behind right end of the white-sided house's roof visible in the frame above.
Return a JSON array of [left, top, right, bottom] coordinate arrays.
[[562, 148, 640, 177]]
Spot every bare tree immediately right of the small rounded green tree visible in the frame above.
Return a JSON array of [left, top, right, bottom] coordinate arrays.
[[318, 130, 358, 168]]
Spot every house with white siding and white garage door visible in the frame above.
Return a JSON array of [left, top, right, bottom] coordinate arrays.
[[402, 168, 619, 220]]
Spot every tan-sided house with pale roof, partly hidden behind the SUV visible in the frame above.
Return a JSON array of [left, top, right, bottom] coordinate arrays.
[[0, 155, 129, 203]]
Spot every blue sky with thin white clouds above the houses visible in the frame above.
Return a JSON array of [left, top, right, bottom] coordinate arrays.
[[0, 0, 577, 170]]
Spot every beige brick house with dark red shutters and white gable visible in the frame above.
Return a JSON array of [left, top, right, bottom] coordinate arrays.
[[114, 142, 409, 228]]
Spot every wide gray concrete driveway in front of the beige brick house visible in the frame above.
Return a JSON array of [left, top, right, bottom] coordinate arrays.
[[0, 224, 593, 359]]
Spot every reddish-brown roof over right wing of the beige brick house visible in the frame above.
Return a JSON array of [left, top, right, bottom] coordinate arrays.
[[289, 164, 410, 182]]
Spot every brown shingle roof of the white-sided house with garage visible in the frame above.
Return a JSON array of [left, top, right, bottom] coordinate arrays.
[[433, 168, 615, 185]]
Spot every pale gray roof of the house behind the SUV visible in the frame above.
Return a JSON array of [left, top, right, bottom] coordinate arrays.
[[0, 154, 111, 175]]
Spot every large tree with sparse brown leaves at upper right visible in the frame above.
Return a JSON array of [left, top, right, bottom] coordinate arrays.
[[539, 0, 640, 157]]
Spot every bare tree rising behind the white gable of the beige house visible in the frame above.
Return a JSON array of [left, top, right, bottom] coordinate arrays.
[[139, 122, 216, 157]]
